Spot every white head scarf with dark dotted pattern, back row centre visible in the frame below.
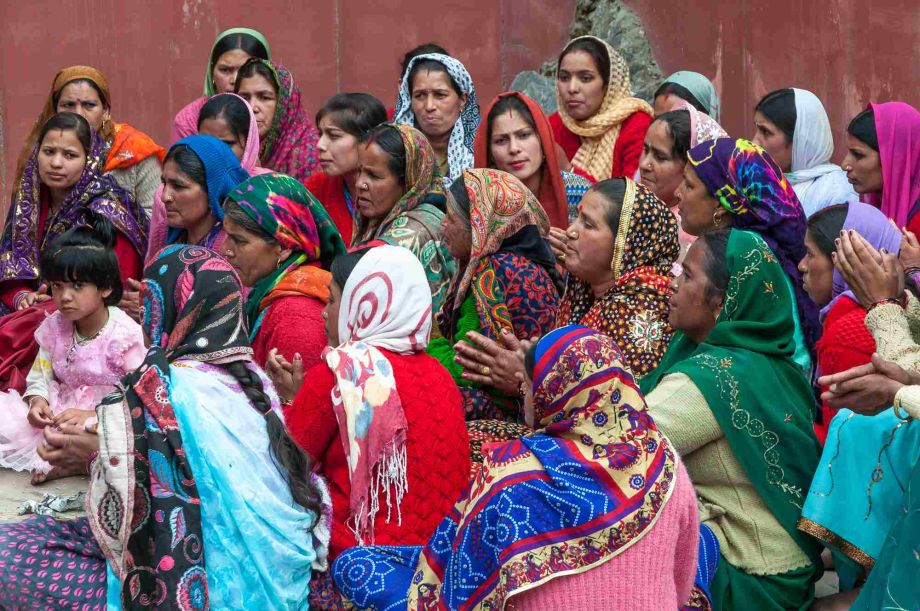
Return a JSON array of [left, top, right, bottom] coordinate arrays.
[[393, 53, 480, 185]]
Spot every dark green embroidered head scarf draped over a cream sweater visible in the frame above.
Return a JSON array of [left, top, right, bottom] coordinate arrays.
[[641, 229, 821, 570]]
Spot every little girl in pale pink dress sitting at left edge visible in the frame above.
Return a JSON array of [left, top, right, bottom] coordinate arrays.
[[0, 212, 147, 484]]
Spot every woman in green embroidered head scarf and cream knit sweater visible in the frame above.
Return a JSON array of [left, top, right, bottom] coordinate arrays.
[[641, 229, 821, 609]]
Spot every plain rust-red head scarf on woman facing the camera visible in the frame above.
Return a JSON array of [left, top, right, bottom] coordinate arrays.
[[473, 91, 569, 229]]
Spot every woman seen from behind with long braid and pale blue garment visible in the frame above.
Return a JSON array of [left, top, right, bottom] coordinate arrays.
[[0, 246, 325, 609]]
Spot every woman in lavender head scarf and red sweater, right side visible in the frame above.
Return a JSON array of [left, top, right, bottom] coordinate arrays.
[[799, 202, 901, 444]]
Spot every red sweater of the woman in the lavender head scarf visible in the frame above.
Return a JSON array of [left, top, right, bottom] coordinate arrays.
[[815, 297, 875, 444]]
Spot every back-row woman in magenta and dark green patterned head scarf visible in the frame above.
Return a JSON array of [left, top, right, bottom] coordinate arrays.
[[233, 58, 320, 182]]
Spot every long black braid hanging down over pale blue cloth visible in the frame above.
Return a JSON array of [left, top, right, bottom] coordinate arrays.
[[223, 361, 323, 531]]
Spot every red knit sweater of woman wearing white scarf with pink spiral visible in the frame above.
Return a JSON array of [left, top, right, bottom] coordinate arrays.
[[284, 350, 470, 560]]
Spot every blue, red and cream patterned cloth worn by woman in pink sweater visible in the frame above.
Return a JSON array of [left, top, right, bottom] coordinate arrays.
[[333, 326, 677, 609]]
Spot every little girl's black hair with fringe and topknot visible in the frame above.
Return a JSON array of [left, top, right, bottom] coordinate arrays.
[[39, 209, 124, 305]]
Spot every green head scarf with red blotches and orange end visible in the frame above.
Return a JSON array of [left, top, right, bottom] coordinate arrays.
[[227, 174, 345, 338]]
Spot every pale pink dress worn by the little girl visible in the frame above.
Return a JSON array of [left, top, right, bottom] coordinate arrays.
[[0, 307, 147, 473]]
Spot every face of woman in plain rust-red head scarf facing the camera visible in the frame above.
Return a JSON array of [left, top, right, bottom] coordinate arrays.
[[489, 110, 543, 184]]
